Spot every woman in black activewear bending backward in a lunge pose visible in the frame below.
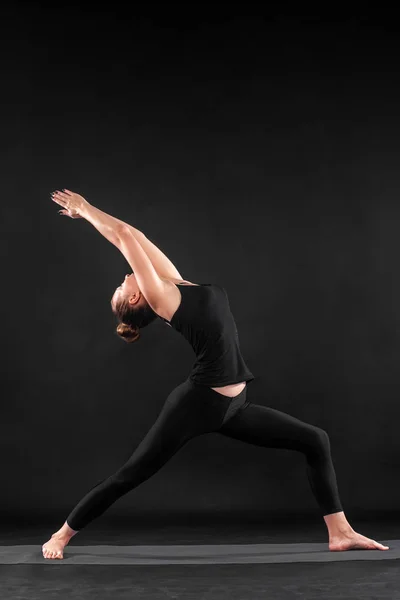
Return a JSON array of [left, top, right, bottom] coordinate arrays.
[[42, 190, 388, 558]]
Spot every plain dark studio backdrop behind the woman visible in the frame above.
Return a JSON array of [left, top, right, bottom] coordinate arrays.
[[0, 3, 400, 525]]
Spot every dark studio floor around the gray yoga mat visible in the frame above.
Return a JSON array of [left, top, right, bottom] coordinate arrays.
[[0, 515, 400, 600]]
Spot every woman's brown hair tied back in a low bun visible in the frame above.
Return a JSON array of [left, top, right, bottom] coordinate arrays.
[[111, 298, 158, 342]]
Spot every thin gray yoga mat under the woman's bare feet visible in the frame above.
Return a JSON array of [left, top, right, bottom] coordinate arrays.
[[0, 540, 400, 565]]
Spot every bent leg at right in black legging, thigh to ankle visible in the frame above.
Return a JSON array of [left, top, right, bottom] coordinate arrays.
[[218, 402, 342, 515]]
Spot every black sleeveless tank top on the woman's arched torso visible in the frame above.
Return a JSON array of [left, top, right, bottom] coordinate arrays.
[[160, 283, 254, 387]]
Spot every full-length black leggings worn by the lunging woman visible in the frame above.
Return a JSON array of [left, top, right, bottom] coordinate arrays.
[[67, 379, 342, 531]]
